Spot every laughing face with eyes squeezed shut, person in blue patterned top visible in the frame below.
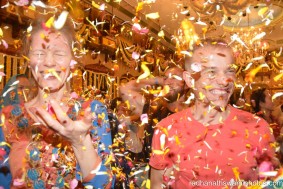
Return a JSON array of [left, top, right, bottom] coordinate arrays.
[[28, 30, 72, 90]]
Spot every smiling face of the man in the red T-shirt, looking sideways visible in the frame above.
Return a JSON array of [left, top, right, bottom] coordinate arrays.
[[184, 47, 236, 108]]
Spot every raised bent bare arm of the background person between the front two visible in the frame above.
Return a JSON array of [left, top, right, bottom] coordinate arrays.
[[119, 77, 163, 115]]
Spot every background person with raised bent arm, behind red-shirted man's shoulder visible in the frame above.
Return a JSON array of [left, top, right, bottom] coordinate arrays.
[[120, 66, 191, 162]]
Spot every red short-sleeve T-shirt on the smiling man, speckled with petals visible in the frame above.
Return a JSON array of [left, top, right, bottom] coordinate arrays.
[[150, 107, 274, 188]]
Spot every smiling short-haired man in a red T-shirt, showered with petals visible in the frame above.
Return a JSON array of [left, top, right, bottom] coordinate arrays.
[[150, 40, 274, 189]]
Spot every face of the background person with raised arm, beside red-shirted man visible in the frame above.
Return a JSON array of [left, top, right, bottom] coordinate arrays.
[[164, 68, 185, 102]]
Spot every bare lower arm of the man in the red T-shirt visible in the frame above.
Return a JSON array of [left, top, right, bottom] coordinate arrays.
[[150, 167, 173, 189]]
